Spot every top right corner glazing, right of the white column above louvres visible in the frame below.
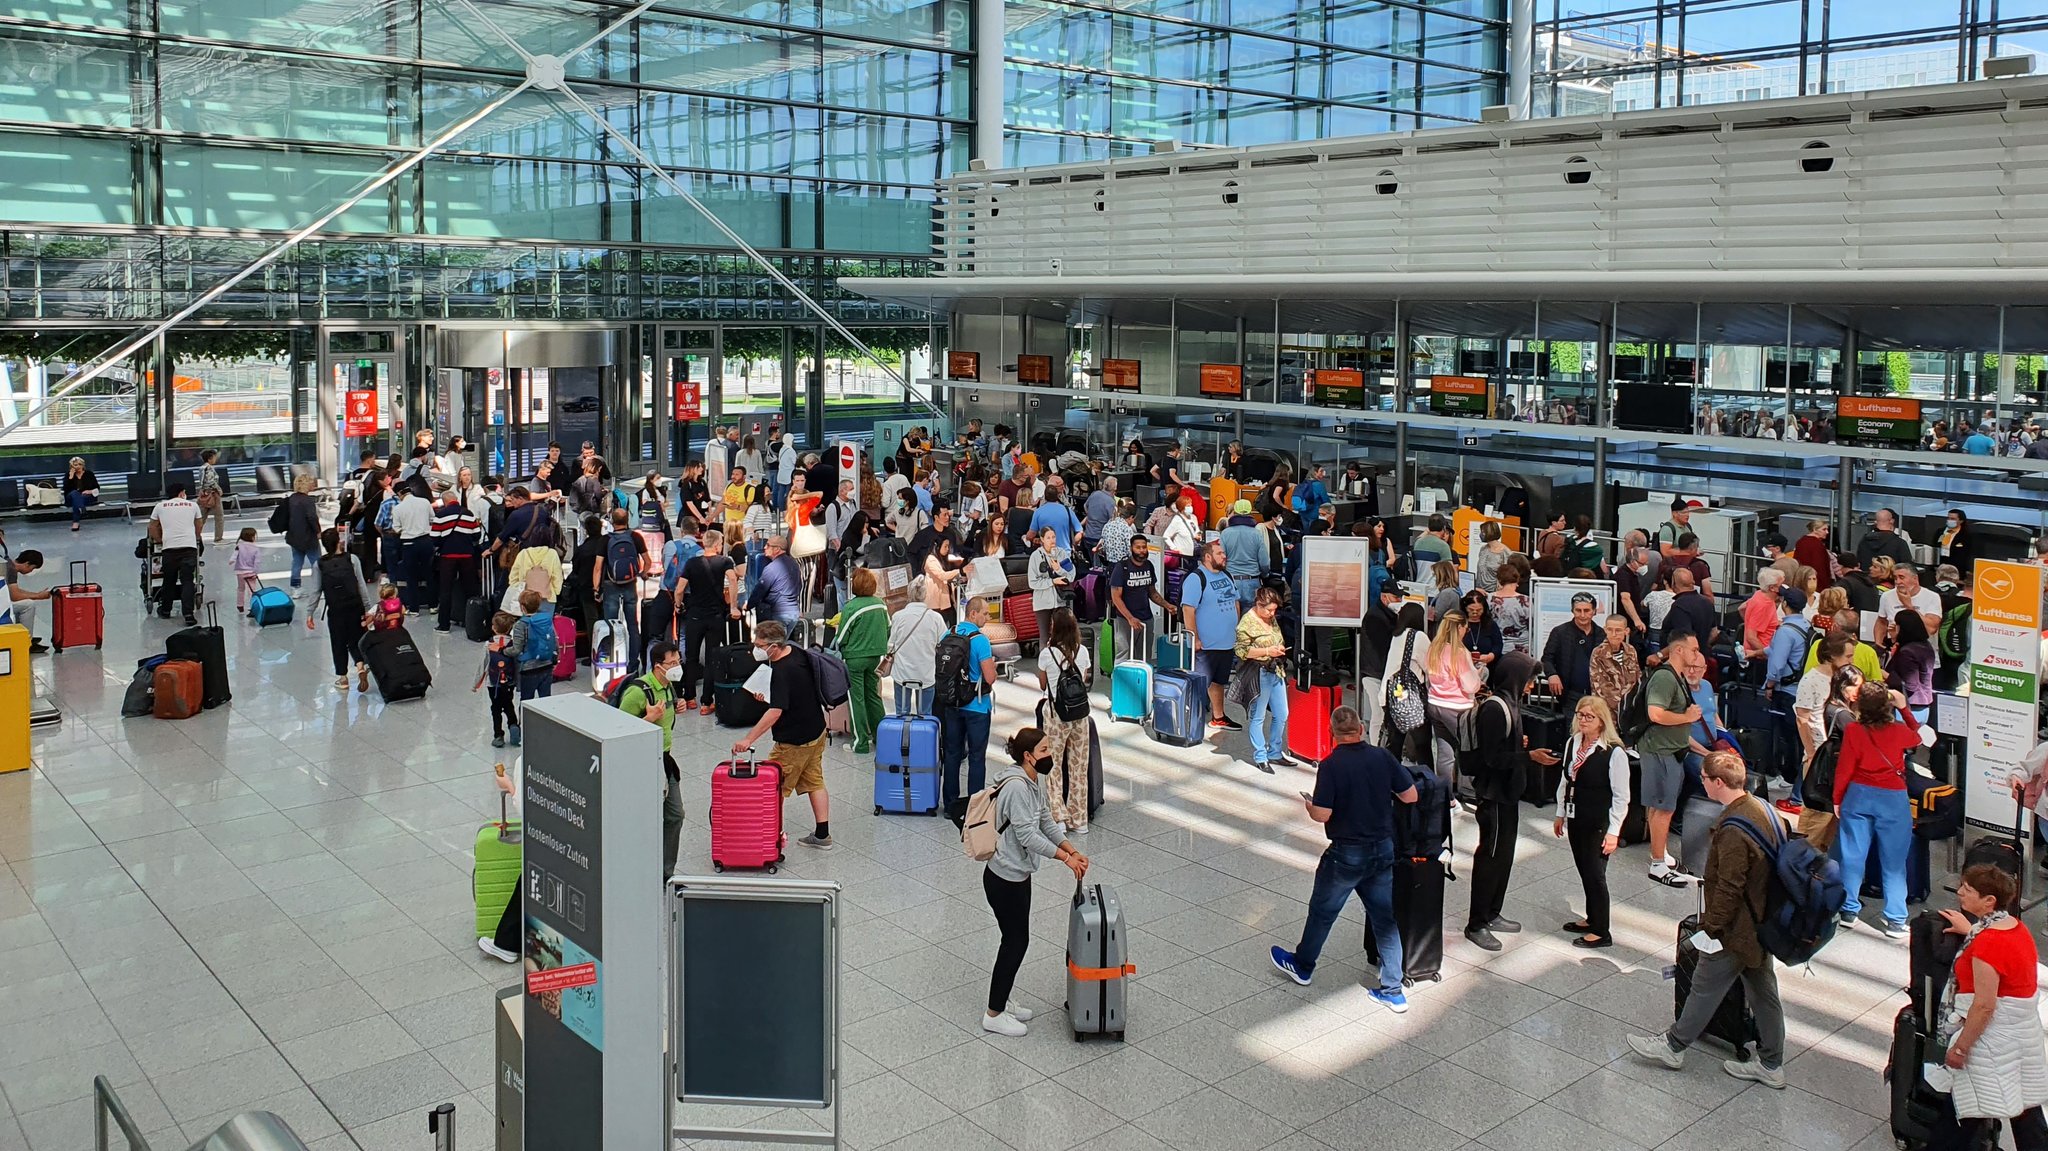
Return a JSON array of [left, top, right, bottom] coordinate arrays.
[[1532, 0, 2048, 117]]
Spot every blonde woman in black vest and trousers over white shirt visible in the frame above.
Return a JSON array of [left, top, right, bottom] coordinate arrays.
[[1550, 696, 1628, 948]]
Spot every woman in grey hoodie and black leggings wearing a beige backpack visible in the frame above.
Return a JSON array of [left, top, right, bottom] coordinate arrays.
[[981, 727, 1087, 1038]]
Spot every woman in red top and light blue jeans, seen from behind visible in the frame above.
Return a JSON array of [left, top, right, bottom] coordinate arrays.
[[1835, 682, 1921, 938]]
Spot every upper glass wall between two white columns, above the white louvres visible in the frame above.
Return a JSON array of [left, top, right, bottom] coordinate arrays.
[[1004, 0, 1507, 166]]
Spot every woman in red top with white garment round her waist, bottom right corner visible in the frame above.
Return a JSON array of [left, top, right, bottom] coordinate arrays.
[[1937, 864, 2048, 1151]]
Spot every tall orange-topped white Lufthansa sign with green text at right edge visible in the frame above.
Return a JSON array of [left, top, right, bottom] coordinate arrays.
[[1962, 559, 2042, 832]]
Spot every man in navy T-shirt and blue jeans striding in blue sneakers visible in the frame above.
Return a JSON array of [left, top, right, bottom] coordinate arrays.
[[1272, 707, 1415, 1014]]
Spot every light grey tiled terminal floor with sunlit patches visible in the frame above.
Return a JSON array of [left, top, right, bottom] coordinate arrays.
[[0, 516, 1939, 1151]]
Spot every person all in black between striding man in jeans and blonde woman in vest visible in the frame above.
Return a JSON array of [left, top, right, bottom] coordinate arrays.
[[1464, 651, 1559, 950]]
